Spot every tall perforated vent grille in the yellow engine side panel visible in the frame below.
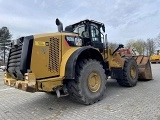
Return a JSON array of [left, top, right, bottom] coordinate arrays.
[[48, 37, 59, 74]]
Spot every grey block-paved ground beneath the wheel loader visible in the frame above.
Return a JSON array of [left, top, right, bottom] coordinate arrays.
[[0, 64, 160, 120]]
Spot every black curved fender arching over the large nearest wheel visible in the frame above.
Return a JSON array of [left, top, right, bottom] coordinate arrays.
[[65, 46, 103, 79]]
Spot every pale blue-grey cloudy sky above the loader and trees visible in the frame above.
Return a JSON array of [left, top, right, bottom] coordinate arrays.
[[0, 0, 160, 43]]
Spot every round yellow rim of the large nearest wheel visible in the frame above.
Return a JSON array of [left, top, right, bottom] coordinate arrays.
[[88, 72, 101, 92]]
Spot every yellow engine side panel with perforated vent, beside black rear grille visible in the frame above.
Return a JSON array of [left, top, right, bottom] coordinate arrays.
[[31, 33, 62, 79]]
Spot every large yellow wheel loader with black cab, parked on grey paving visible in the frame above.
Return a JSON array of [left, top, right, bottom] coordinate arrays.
[[4, 19, 152, 105]]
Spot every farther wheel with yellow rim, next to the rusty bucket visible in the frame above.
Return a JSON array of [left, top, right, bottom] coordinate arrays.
[[117, 58, 138, 87]]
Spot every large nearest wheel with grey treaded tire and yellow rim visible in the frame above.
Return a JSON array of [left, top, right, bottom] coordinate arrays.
[[67, 59, 106, 105]]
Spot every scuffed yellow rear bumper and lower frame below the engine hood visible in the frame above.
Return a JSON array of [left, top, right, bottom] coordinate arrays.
[[4, 73, 63, 92]]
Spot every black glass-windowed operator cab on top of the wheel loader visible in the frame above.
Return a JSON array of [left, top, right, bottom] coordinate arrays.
[[65, 19, 105, 51]]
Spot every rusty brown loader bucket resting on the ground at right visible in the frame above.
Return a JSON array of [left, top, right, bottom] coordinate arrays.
[[133, 55, 152, 80]]
